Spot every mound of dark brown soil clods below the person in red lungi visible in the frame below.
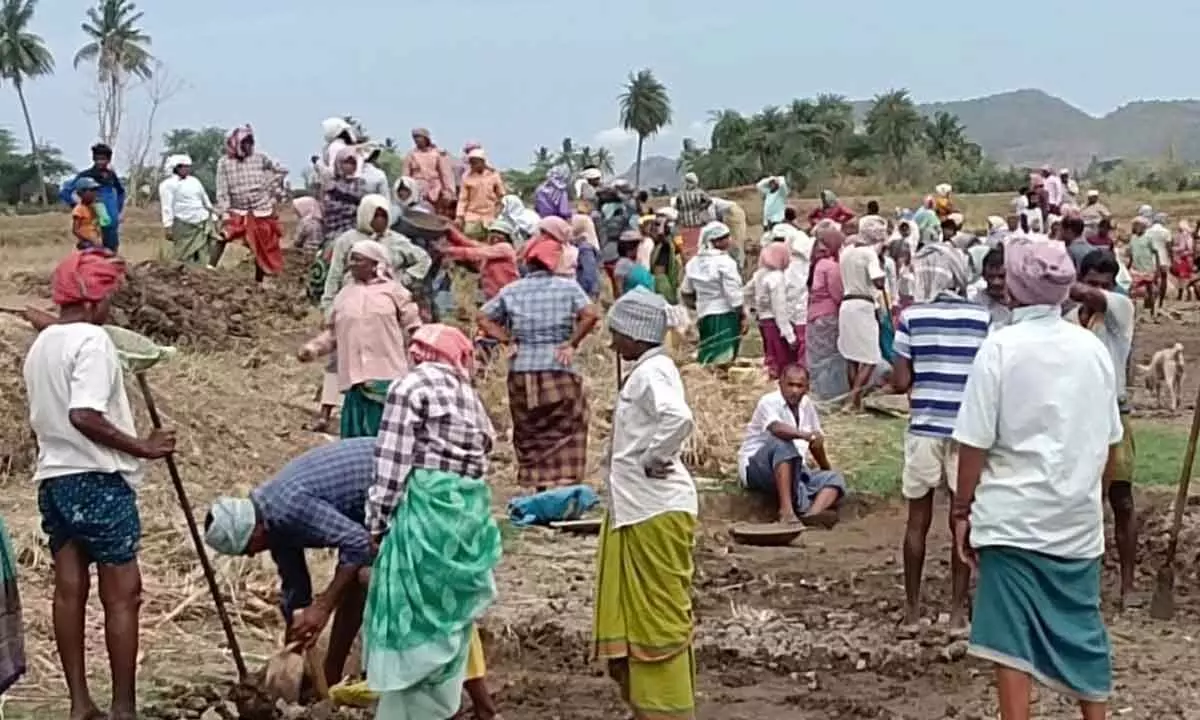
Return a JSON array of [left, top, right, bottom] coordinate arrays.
[[14, 251, 314, 350]]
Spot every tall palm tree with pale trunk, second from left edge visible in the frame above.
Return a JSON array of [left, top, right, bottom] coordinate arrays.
[[74, 0, 155, 146]]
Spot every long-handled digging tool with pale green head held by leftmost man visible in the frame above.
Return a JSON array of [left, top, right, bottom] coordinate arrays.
[[104, 325, 250, 685]]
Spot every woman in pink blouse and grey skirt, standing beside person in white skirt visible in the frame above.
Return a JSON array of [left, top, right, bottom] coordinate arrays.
[[804, 221, 850, 400]]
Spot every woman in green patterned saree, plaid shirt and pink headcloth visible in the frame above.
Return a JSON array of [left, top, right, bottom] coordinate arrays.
[[362, 324, 500, 720]]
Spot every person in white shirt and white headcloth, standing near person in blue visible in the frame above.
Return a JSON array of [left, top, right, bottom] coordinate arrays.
[[158, 155, 218, 265]]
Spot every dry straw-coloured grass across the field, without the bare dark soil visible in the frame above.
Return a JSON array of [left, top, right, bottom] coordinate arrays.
[[0, 193, 1200, 716]]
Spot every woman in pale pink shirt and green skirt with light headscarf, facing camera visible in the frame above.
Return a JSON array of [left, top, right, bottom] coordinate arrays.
[[299, 240, 421, 438]]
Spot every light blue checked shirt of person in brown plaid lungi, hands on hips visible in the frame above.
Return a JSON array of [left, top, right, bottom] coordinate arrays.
[[480, 271, 590, 372]]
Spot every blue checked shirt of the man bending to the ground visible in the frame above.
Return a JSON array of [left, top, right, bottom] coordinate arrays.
[[250, 438, 376, 624]]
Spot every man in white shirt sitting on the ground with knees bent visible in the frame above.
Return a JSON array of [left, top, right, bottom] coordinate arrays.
[[738, 365, 846, 527]]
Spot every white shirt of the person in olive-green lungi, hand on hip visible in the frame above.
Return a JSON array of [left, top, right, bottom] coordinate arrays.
[[608, 348, 700, 528]]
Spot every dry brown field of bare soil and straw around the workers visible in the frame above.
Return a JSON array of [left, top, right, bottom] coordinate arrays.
[[0, 196, 1200, 720]]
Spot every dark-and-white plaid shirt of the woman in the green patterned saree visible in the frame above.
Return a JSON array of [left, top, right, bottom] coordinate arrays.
[[366, 362, 496, 535]]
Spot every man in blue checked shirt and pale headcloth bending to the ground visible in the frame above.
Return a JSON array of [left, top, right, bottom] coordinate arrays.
[[204, 437, 376, 684]]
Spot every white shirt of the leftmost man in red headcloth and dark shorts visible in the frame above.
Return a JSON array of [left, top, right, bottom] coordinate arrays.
[[24, 323, 142, 485]]
